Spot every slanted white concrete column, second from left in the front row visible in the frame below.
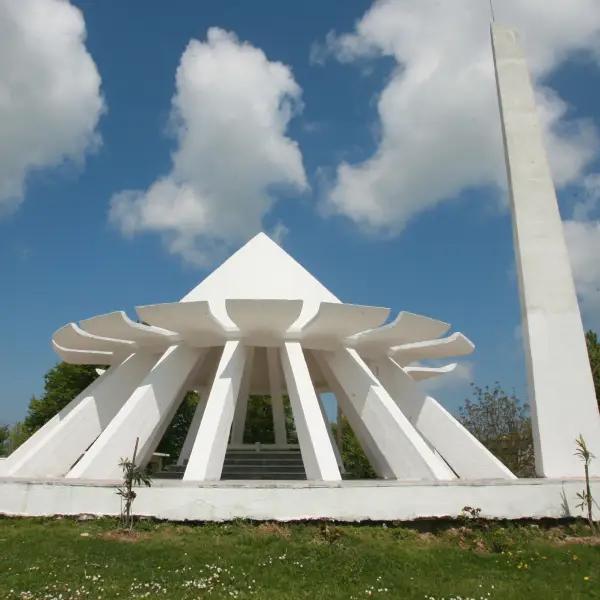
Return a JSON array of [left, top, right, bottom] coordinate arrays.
[[67, 345, 207, 479]]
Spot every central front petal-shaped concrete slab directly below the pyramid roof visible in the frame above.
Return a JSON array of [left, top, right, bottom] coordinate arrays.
[[225, 299, 303, 346]]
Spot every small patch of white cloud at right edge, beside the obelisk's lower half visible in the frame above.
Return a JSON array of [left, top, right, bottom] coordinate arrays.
[[564, 221, 600, 331]]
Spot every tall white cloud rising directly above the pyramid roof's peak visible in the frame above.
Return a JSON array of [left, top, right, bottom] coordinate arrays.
[[110, 28, 307, 264]]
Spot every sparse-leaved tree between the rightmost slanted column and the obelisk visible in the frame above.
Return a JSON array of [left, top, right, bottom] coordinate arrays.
[[459, 382, 535, 477]]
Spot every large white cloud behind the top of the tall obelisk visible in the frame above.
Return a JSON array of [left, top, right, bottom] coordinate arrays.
[[312, 0, 600, 233]]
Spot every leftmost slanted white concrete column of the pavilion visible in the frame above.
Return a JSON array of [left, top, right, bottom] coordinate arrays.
[[4, 353, 158, 477]]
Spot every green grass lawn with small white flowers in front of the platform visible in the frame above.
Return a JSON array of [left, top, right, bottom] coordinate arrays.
[[0, 519, 600, 600]]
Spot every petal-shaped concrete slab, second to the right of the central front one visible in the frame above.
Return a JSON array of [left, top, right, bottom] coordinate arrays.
[[348, 311, 450, 354]]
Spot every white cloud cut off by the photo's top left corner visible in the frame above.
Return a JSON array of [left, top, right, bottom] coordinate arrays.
[[0, 0, 104, 212]]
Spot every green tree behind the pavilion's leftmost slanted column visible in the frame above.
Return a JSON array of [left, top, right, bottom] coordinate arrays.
[[24, 362, 98, 434]]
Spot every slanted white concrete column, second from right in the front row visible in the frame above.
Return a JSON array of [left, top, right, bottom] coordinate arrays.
[[314, 348, 455, 480]]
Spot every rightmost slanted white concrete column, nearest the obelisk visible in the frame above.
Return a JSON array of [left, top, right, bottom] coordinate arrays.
[[373, 357, 516, 479]]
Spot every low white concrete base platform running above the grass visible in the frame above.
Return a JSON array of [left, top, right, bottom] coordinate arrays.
[[0, 478, 600, 521]]
